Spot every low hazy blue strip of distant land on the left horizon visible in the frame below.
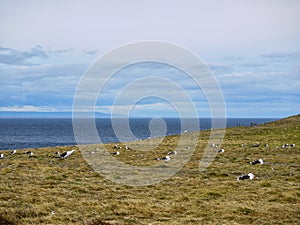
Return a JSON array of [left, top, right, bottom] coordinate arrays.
[[0, 111, 111, 118]]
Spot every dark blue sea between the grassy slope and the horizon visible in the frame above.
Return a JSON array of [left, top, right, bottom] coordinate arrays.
[[0, 118, 278, 150]]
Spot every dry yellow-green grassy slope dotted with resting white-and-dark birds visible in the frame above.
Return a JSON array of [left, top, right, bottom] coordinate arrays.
[[0, 115, 300, 225]]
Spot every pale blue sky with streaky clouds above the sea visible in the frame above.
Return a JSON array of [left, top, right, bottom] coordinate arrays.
[[0, 0, 300, 118]]
